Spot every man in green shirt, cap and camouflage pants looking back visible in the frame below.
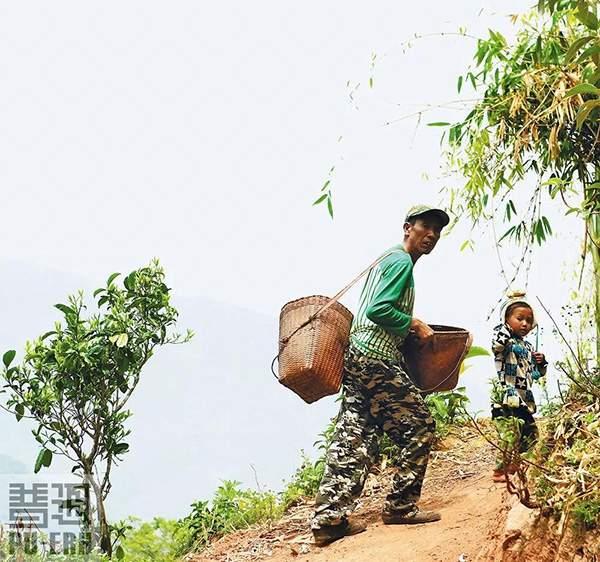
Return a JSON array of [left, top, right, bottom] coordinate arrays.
[[312, 205, 450, 546]]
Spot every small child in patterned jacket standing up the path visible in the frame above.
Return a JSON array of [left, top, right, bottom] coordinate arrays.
[[492, 292, 548, 482]]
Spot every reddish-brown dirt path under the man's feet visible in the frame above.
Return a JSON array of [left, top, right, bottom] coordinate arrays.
[[192, 424, 506, 562]]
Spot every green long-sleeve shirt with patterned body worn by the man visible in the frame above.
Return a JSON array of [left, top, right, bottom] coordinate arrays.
[[350, 245, 415, 361]]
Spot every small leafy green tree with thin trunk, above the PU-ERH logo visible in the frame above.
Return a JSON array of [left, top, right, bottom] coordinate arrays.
[[2, 261, 192, 556]]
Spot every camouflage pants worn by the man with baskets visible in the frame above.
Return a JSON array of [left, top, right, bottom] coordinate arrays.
[[312, 348, 435, 529]]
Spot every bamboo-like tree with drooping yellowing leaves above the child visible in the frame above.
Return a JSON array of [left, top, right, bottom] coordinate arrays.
[[437, 0, 600, 358]]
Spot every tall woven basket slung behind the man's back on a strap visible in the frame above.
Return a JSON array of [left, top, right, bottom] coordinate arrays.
[[278, 295, 352, 404]]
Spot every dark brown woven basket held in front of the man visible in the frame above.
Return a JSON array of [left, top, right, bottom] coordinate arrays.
[[404, 325, 473, 393]]
